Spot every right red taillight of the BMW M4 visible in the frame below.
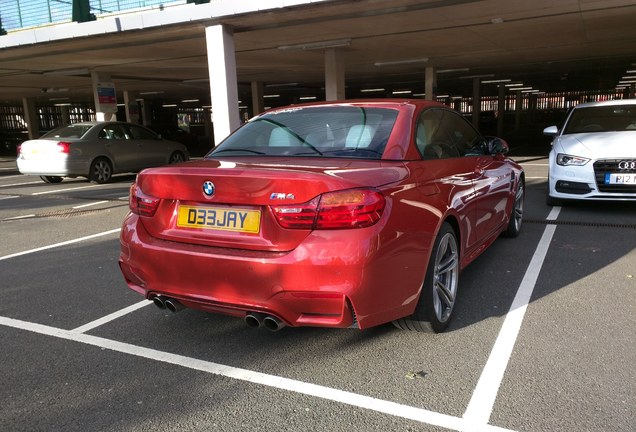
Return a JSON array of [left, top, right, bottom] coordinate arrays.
[[271, 189, 386, 229]]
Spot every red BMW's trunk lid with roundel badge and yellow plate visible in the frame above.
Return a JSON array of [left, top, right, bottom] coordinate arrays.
[[137, 157, 407, 252]]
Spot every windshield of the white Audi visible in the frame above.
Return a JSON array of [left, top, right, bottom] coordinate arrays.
[[563, 105, 636, 135]]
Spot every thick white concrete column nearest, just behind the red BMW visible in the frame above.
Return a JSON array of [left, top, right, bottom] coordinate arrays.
[[205, 24, 241, 143]]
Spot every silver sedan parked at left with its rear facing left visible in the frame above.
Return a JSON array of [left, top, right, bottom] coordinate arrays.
[[17, 122, 189, 183]]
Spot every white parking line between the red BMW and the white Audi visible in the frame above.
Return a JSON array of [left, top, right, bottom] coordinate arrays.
[[463, 207, 561, 431]]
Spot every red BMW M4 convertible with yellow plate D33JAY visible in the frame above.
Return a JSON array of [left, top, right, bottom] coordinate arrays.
[[119, 99, 525, 332]]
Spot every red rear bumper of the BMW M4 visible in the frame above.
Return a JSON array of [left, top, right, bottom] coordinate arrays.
[[119, 214, 404, 328]]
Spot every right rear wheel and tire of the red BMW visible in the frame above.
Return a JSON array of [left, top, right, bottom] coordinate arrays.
[[393, 222, 459, 333]]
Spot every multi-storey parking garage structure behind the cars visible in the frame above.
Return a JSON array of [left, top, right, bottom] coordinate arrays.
[[0, 0, 636, 155]]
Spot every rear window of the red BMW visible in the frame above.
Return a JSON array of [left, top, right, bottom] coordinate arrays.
[[206, 106, 398, 159]]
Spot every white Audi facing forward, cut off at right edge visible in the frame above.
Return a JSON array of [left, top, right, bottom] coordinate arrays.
[[543, 99, 636, 205]]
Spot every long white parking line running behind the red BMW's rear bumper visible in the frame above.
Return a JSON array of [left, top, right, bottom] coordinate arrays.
[[0, 317, 512, 432]]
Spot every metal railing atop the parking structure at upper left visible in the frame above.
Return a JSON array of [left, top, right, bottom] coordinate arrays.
[[0, 0, 191, 34]]
